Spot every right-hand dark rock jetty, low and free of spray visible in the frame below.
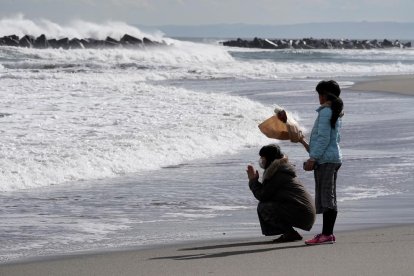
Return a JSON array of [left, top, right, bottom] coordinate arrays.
[[222, 37, 411, 49]]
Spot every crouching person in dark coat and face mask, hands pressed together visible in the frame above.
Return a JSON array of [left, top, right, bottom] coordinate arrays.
[[247, 144, 315, 243]]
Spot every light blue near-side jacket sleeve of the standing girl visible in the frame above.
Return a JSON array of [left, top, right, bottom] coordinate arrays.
[[309, 108, 332, 160]]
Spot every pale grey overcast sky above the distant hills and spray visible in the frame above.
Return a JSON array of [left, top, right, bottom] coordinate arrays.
[[0, 0, 414, 25]]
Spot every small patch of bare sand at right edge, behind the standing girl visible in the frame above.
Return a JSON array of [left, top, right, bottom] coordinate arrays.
[[350, 75, 414, 96]]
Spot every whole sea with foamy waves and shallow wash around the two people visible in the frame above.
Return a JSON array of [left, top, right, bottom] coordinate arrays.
[[0, 19, 414, 262]]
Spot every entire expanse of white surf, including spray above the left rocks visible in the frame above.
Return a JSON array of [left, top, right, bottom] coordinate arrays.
[[0, 16, 414, 190]]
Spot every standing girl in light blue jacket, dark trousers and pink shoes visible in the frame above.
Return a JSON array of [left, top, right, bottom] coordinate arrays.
[[301, 80, 343, 245]]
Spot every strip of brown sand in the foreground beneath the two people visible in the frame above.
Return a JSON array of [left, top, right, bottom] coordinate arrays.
[[0, 225, 414, 276]]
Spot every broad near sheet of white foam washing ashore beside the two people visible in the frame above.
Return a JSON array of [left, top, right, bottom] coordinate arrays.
[[0, 74, 271, 190]]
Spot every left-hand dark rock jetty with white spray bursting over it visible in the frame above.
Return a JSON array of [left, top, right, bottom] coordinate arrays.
[[0, 34, 166, 49]]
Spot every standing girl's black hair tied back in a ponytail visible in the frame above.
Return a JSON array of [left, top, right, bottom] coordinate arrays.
[[316, 80, 344, 129]]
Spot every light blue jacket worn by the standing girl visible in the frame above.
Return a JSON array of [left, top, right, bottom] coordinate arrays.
[[309, 106, 342, 164]]
